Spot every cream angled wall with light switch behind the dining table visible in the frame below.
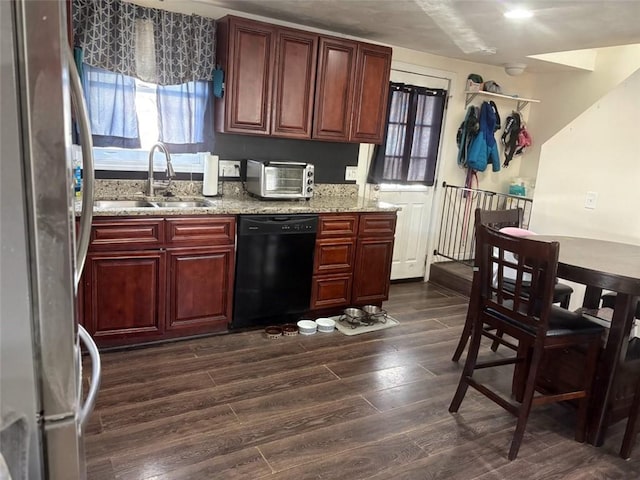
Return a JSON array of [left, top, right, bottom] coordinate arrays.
[[531, 70, 640, 308]]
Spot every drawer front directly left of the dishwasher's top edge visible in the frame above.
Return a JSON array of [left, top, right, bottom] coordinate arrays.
[[166, 217, 236, 247]]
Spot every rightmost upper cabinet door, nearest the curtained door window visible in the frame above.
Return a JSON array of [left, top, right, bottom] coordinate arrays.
[[349, 43, 391, 143]]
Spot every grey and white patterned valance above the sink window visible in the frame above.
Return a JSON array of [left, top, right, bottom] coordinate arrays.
[[73, 0, 216, 85]]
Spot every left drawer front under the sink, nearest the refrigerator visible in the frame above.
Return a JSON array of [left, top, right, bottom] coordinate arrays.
[[89, 218, 164, 251]]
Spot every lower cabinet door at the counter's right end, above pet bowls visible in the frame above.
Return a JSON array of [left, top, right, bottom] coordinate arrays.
[[351, 238, 393, 305]]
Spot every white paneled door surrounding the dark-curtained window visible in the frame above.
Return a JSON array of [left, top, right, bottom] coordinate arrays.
[[379, 69, 449, 280]]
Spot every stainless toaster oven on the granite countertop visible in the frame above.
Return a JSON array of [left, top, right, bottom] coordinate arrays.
[[246, 160, 314, 199]]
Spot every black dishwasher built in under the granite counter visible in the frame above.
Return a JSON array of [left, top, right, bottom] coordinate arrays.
[[231, 215, 318, 328]]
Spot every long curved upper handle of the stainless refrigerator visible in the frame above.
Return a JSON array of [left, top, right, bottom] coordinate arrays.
[[66, 49, 94, 287]]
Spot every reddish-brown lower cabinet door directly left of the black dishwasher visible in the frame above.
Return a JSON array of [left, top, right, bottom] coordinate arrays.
[[167, 246, 234, 334]]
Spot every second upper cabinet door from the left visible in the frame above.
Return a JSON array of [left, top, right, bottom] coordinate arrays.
[[271, 29, 318, 138]]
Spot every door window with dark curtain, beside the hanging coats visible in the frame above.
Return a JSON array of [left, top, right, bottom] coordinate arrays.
[[368, 82, 447, 186]]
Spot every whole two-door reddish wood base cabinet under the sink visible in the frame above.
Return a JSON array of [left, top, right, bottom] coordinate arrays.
[[84, 215, 235, 347]]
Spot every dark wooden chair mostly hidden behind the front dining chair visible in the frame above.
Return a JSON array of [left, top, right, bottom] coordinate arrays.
[[451, 208, 573, 362]]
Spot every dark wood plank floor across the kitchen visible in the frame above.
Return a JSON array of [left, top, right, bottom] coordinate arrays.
[[86, 283, 640, 480]]
